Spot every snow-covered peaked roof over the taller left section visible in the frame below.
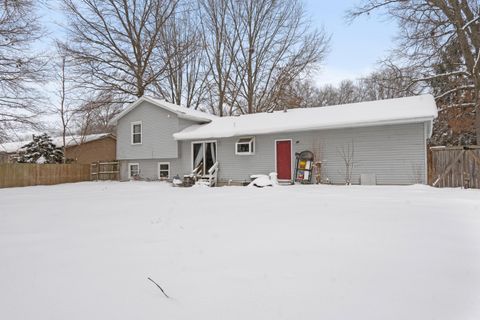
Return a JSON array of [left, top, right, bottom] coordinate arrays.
[[110, 96, 217, 124]]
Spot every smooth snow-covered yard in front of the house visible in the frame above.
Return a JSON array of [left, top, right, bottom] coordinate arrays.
[[0, 182, 480, 320]]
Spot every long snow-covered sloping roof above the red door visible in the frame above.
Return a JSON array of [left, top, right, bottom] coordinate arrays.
[[173, 95, 437, 140]]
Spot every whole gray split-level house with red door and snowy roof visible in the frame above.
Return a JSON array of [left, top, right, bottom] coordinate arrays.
[[112, 95, 437, 185]]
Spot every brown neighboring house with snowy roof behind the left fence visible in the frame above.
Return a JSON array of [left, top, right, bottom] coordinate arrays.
[[0, 133, 116, 164]]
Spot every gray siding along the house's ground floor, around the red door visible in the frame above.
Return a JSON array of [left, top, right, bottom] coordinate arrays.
[[117, 119, 426, 184]]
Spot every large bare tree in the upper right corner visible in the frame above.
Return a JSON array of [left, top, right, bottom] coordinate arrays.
[[349, 0, 480, 139]]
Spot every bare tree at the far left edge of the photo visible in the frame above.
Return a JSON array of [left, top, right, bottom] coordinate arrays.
[[0, 0, 46, 140]]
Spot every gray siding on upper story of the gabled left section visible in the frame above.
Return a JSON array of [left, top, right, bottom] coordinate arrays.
[[117, 101, 198, 160]]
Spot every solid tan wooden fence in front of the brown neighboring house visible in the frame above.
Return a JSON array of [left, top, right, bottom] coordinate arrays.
[[0, 163, 90, 188]]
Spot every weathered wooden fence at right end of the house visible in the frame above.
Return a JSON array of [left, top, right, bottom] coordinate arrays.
[[429, 146, 480, 188]]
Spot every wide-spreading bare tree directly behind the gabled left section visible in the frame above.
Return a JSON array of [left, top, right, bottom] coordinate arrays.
[[62, 0, 177, 101]]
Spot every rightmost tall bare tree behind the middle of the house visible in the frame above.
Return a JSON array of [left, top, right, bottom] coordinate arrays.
[[229, 0, 329, 113]]
